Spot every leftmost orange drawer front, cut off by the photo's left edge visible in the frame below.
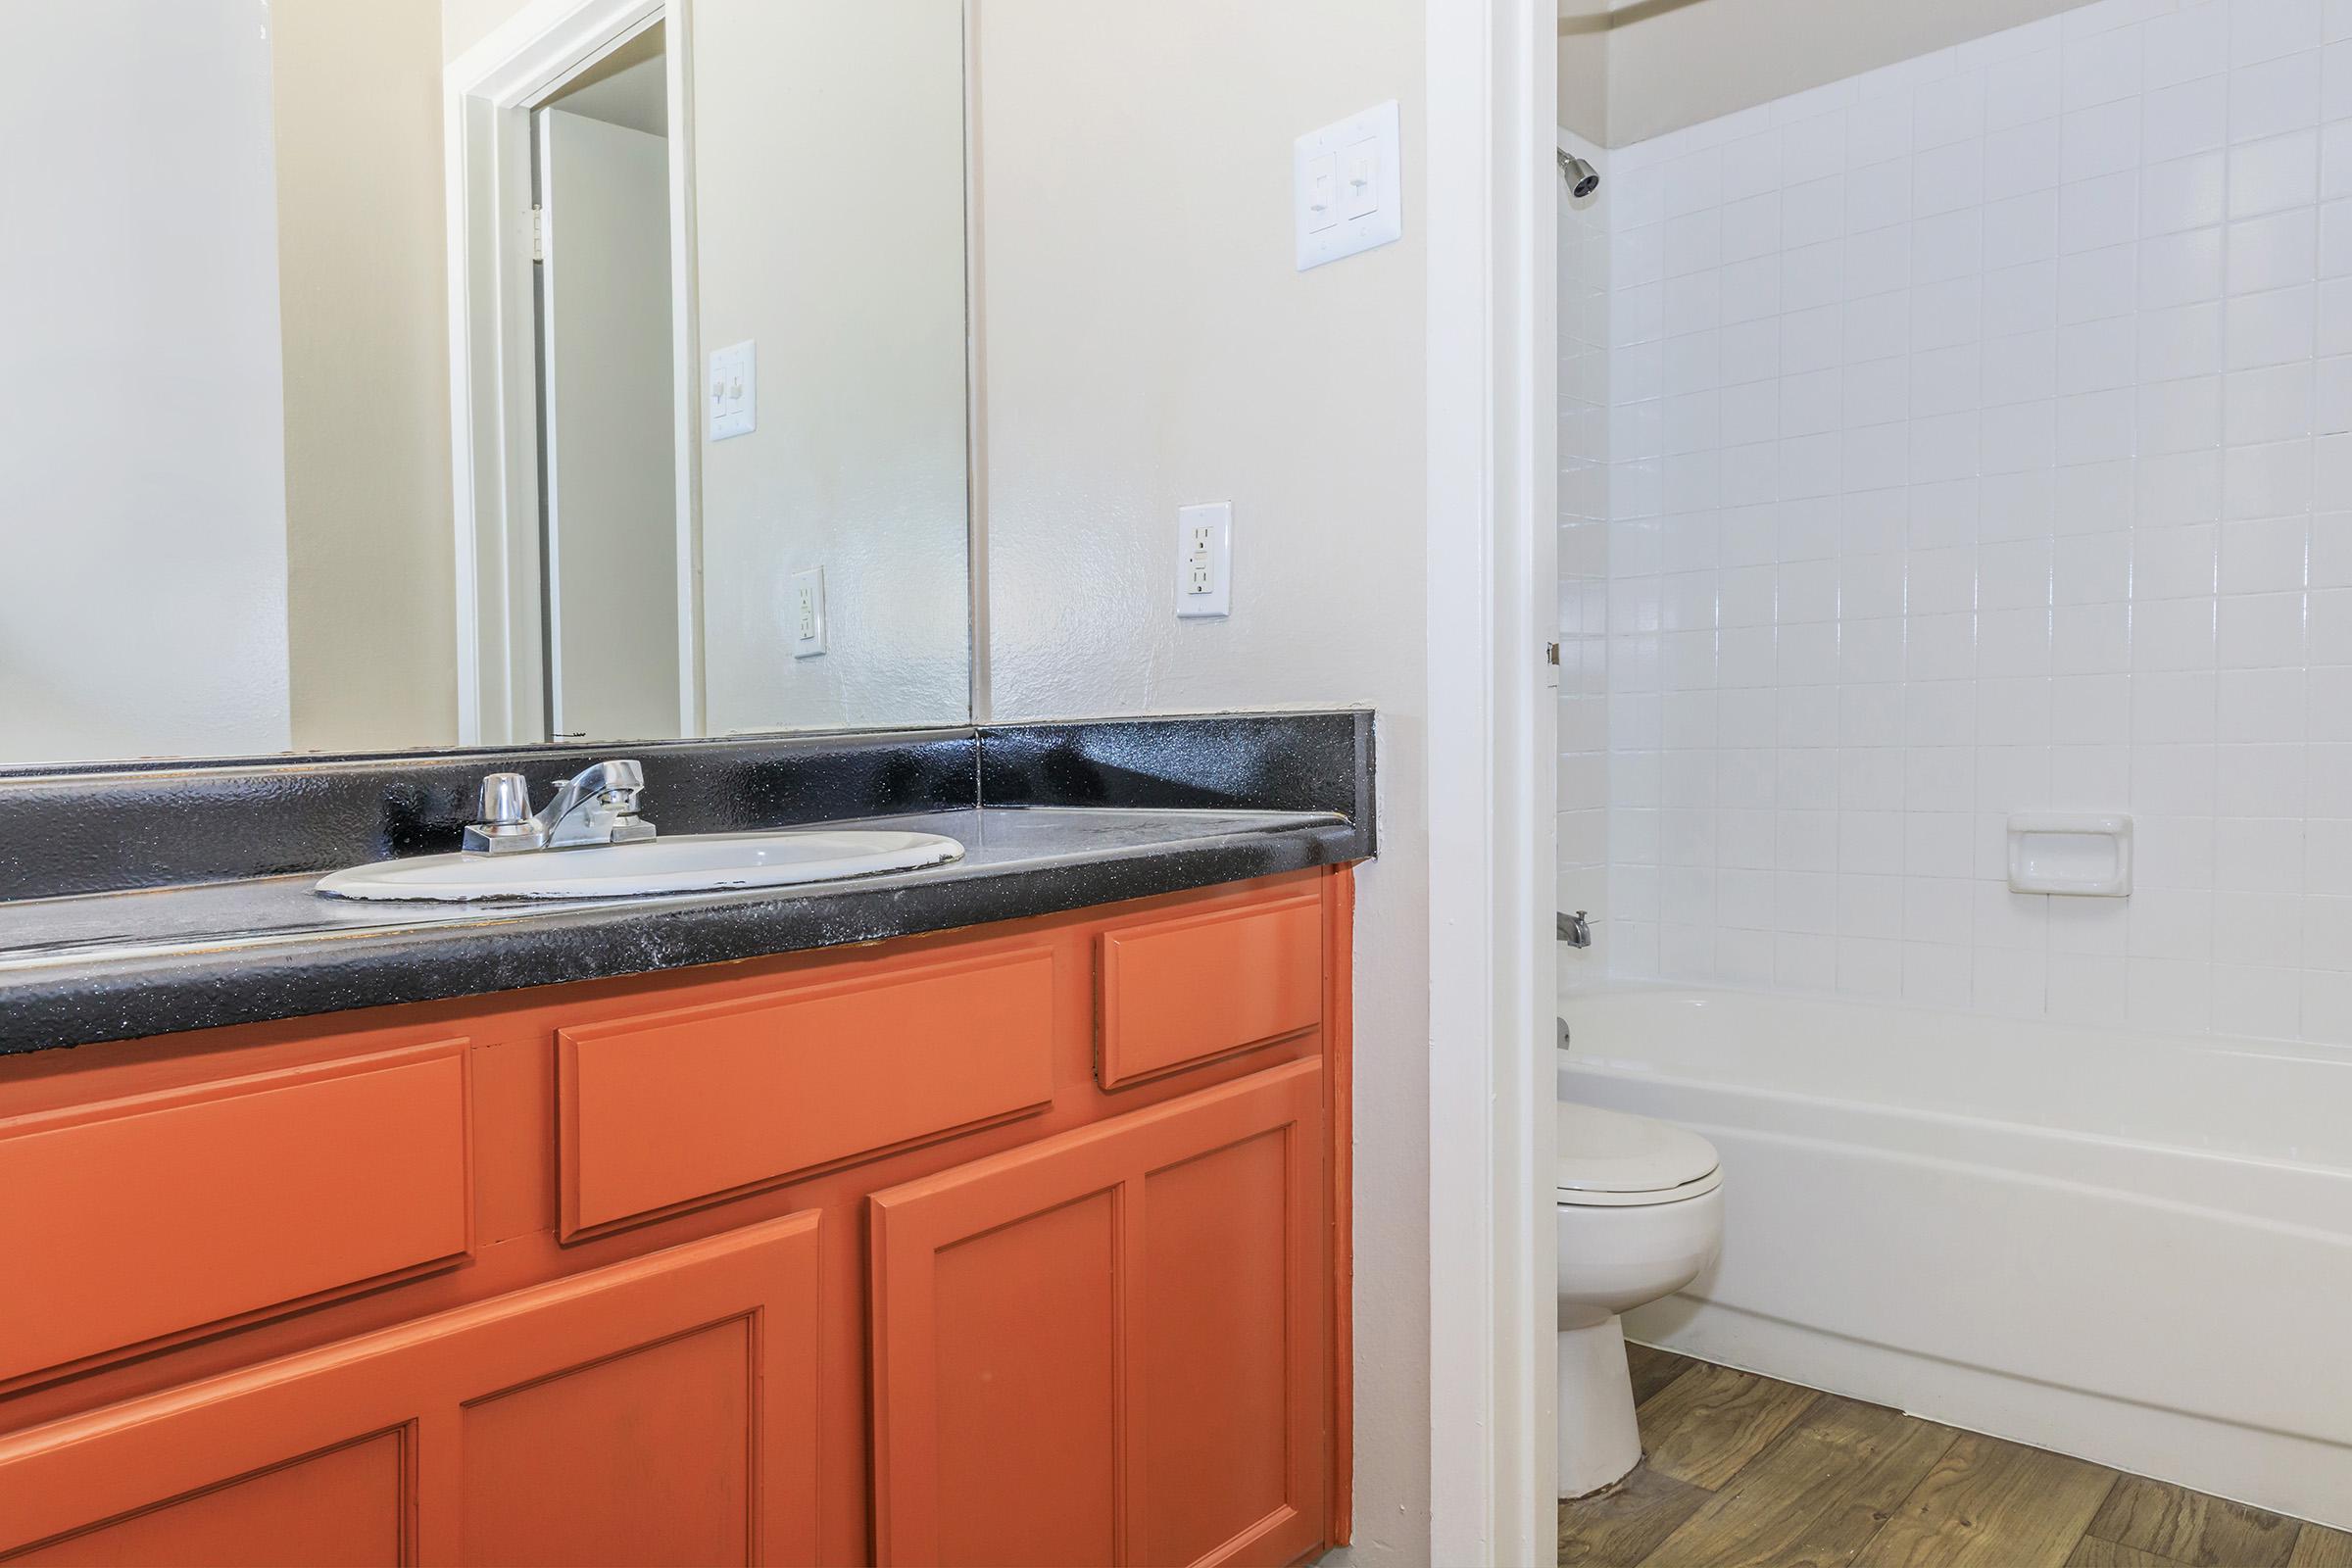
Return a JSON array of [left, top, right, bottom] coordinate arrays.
[[0, 1042, 472, 1385]]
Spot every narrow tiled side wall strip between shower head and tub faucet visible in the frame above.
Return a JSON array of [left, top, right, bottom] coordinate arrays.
[[1557, 131, 1609, 973]]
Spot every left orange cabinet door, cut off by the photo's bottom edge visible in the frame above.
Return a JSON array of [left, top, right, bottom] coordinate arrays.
[[0, 1213, 818, 1568]]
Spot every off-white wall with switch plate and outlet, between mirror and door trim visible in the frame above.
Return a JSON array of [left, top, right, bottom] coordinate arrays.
[[974, 0, 1430, 1563]]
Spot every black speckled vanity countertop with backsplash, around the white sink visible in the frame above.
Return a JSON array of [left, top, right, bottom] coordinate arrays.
[[0, 712, 1374, 1054]]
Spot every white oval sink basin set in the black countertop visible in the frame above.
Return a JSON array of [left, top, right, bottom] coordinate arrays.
[[318, 827, 964, 903]]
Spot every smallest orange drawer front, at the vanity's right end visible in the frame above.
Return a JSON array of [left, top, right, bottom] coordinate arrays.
[[1096, 894, 1322, 1089]]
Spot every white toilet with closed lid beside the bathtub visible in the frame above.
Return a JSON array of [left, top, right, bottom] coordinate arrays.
[[1559, 1101, 1724, 1497]]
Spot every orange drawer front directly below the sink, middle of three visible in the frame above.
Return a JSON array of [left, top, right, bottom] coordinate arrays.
[[555, 948, 1054, 1242]]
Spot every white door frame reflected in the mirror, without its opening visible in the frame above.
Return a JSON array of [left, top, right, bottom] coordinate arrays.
[[442, 0, 704, 745]]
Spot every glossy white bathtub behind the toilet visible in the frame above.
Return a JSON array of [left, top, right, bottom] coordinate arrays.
[[1559, 987, 2352, 1526]]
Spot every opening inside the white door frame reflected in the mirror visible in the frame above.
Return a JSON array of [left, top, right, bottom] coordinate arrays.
[[531, 25, 682, 741]]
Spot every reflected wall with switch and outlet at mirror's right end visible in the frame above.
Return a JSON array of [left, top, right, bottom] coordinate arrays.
[[694, 0, 971, 733]]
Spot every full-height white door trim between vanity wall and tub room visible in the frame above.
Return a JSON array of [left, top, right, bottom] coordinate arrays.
[[1423, 0, 1559, 1566]]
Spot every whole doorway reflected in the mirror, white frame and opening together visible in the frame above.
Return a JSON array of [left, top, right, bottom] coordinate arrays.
[[445, 0, 704, 745]]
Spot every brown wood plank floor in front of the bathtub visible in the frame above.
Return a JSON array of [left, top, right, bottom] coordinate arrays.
[[1559, 1345, 2352, 1568]]
